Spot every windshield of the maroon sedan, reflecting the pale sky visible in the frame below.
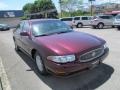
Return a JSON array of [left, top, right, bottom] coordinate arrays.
[[32, 20, 72, 36]]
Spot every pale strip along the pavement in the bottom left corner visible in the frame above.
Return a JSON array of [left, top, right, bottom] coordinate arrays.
[[0, 57, 11, 90]]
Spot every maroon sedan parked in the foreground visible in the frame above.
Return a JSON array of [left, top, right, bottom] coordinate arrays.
[[13, 19, 109, 75]]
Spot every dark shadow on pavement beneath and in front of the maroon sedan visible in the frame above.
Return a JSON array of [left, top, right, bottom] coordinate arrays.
[[18, 52, 114, 90]]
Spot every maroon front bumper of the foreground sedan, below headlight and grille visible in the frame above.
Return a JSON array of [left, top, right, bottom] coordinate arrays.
[[47, 48, 109, 75]]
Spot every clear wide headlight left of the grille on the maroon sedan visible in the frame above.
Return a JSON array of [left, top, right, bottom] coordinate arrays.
[[47, 55, 75, 63]]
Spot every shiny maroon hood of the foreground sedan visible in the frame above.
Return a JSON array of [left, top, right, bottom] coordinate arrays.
[[36, 32, 105, 55]]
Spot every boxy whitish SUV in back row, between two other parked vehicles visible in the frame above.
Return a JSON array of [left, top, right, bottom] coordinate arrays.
[[72, 16, 92, 28]]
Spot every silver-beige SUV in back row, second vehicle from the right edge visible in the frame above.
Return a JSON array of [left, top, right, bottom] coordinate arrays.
[[91, 15, 114, 29]]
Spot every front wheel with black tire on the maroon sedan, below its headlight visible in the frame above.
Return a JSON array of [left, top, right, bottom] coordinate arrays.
[[34, 52, 48, 75]]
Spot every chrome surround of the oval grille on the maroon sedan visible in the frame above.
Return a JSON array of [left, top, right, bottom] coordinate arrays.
[[79, 47, 104, 62]]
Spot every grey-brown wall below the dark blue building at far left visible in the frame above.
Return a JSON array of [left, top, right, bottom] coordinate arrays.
[[0, 18, 21, 27]]
